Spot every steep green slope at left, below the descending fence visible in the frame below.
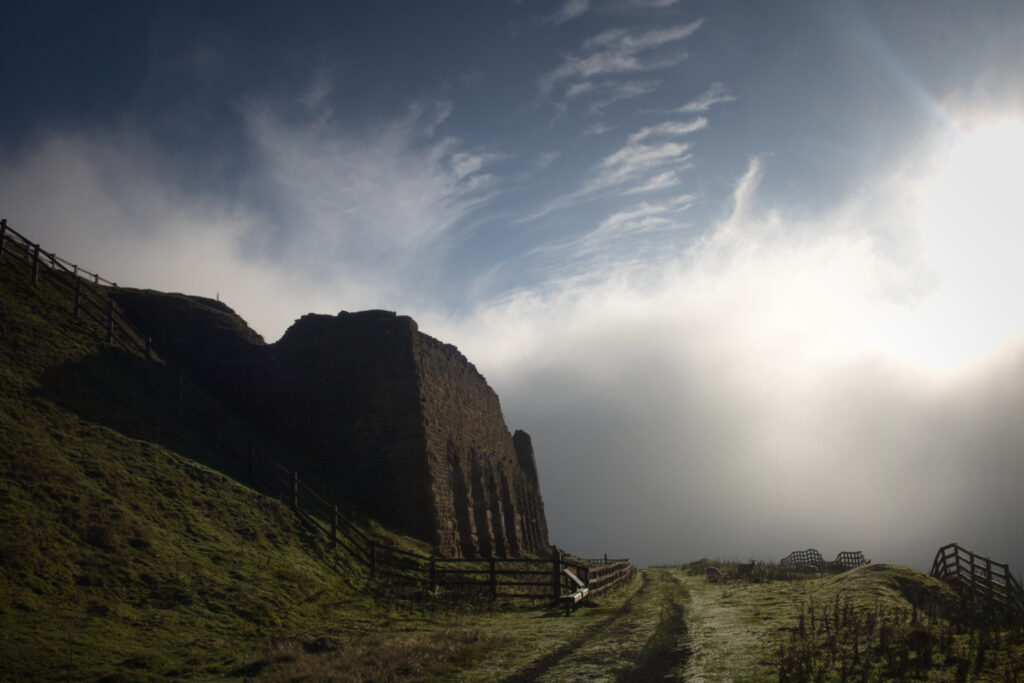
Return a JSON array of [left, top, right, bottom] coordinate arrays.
[[0, 255, 371, 680]]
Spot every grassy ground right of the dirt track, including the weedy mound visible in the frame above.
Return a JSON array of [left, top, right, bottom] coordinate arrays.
[[675, 562, 1024, 681]]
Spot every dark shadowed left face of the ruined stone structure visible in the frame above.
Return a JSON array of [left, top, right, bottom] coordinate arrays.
[[236, 311, 435, 541]]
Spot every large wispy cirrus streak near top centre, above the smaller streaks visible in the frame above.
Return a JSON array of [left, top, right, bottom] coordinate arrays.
[[538, 19, 703, 95]]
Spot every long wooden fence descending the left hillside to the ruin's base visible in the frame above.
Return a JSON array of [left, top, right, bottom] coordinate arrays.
[[0, 220, 636, 600]]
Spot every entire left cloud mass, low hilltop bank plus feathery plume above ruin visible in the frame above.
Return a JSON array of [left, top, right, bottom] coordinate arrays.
[[0, 95, 500, 340]]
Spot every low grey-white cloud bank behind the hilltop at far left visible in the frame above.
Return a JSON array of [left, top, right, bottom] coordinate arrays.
[[0, 132, 356, 340]]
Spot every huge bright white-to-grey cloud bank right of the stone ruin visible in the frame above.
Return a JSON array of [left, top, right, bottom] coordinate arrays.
[[430, 150, 1024, 568]]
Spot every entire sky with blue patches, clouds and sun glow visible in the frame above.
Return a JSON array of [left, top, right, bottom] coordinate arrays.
[[0, 0, 1024, 577]]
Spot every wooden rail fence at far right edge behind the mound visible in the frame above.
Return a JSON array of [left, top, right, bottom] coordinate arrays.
[[931, 543, 1024, 616]]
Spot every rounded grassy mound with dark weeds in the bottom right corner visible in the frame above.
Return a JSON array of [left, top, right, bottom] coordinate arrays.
[[778, 564, 1024, 681]]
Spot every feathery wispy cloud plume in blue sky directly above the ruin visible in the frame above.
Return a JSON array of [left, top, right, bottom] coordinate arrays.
[[243, 90, 500, 279]]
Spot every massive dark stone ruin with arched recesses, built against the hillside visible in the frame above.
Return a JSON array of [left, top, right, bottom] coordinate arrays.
[[115, 295, 548, 557]]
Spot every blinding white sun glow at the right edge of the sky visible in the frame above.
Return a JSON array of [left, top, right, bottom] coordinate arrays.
[[884, 120, 1024, 369]]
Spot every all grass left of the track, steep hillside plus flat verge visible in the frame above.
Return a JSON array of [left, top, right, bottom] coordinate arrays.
[[0, 237, 643, 681]]
